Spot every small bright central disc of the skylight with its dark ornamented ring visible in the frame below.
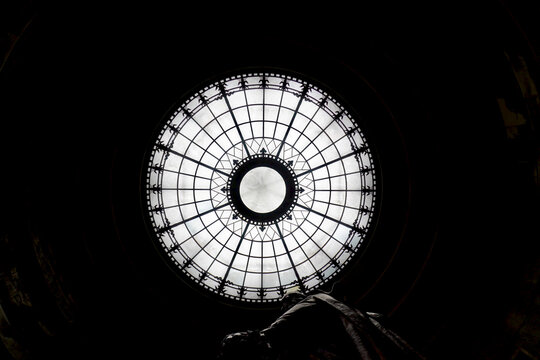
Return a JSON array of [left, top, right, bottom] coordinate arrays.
[[227, 154, 298, 225]]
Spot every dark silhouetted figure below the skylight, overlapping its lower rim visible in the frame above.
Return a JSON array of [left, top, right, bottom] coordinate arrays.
[[220, 289, 423, 360]]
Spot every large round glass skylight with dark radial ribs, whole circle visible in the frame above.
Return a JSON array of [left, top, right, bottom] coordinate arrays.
[[144, 72, 378, 303]]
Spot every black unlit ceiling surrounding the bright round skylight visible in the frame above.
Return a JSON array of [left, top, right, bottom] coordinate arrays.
[[0, 1, 540, 359]]
